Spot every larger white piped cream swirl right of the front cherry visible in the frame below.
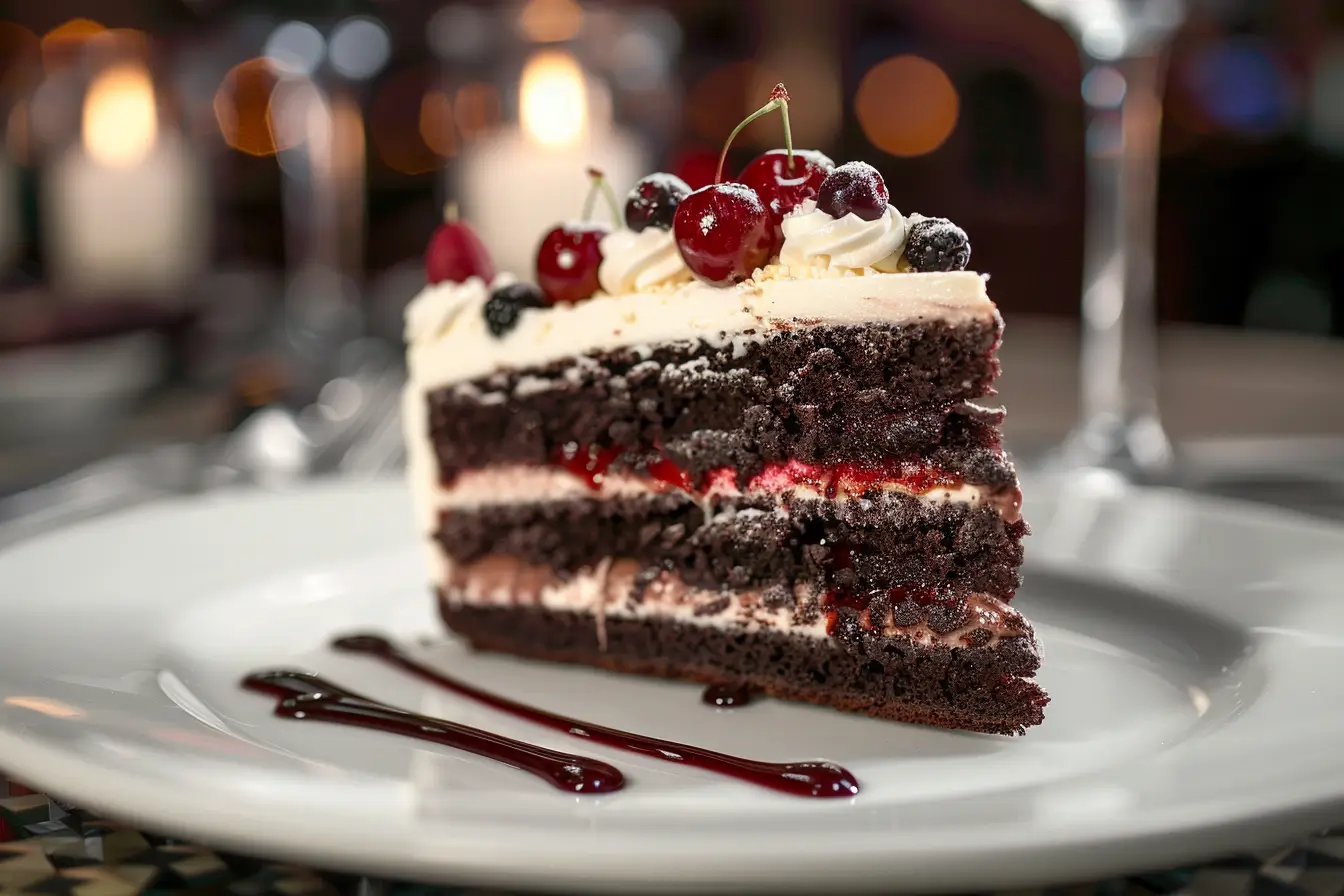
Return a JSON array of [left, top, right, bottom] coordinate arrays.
[[780, 199, 909, 269]]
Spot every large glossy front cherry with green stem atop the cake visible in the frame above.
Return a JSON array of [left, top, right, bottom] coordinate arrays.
[[672, 83, 797, 286]]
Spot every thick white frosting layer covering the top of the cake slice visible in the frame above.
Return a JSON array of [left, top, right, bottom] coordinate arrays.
[[406, 270, 997, 391]]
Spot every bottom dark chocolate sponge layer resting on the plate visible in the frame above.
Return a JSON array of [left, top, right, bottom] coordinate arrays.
[[439, 595, 1048, 735]]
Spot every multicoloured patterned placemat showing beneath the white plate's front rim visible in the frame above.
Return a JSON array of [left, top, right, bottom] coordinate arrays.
[[0, 775, 1344, 896]]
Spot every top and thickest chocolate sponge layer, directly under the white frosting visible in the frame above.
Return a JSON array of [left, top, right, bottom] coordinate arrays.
[[427, 318, 1001, 478]]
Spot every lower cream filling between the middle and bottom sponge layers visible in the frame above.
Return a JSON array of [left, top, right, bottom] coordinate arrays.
[[446, 556, 1031, 647]]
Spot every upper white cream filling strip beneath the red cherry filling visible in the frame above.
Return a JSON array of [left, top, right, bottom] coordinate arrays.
[[437, 463, 985, 509]]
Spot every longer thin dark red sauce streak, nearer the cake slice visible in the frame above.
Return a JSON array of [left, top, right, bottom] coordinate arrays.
[[332, 634, 859, 798]]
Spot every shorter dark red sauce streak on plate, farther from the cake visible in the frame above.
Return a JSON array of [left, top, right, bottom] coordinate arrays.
[[243, 669, 625, 794]]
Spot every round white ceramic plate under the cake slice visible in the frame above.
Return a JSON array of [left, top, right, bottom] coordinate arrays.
[[0, 480, 1344, 892]]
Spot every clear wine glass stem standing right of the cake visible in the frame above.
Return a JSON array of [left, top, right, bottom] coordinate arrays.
[[1078, 52, 1171, 472]]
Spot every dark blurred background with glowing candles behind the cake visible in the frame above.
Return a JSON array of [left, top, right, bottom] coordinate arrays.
[[0, 0, 1344, 510]]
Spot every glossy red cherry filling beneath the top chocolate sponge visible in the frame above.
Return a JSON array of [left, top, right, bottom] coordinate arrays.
[[552, 443, 964, 500]]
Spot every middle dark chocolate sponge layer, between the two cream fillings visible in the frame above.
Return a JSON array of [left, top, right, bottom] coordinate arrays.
[[435, 493, 1027, 599]]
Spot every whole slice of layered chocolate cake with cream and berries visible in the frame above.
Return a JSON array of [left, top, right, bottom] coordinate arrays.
[[405, 89, 1047, 735]]
